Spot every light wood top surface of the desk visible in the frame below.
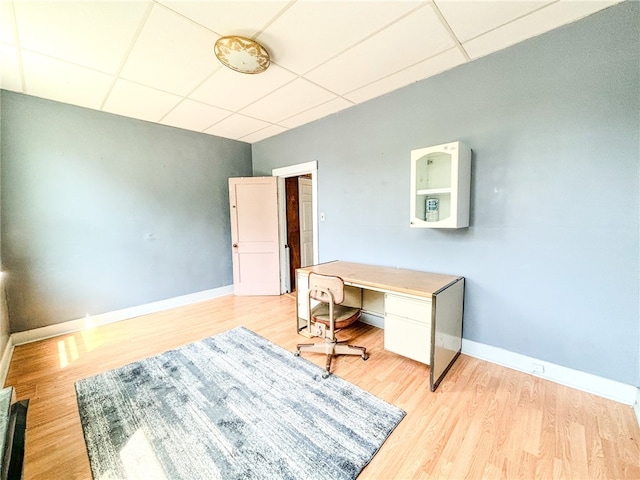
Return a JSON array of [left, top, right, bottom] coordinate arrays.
[[299, 261, 462, 297]]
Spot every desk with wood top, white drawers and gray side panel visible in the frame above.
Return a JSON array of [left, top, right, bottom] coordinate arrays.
[[296, 261, 464, 391]]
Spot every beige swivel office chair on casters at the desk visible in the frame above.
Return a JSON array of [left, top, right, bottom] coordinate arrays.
[[295, 273, 369, 378]]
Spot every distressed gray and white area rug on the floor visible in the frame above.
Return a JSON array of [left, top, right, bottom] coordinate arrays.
[[75, 327, 405, 480]]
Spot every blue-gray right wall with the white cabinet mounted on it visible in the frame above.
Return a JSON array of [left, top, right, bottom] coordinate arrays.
[[252, 2, 640, 385]]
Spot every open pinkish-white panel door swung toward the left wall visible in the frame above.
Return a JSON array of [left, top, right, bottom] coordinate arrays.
[[229, 177, 280, 295]]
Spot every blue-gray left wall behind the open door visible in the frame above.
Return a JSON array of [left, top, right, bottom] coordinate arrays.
[[1, 91, 251, 332]]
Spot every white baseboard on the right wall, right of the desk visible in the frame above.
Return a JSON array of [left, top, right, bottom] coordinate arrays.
[[462, 338, 640, 406]]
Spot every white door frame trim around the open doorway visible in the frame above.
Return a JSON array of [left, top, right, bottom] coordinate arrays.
[[271, 160, 320, 293]]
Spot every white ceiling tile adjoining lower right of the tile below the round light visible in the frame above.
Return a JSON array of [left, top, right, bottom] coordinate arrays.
[[241, 78, 336, 123]]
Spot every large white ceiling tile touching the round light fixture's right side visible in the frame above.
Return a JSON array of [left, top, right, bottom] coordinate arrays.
[[258, 0, 421, 74]]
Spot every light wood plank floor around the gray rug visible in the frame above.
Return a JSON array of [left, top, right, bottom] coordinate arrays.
[[6, 295, 640, 480]]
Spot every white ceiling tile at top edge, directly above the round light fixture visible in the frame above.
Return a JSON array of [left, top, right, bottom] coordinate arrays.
[[159, 0, 289, 37]]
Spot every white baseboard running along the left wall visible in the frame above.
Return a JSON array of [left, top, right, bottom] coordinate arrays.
[[10, 285, 233, 346]]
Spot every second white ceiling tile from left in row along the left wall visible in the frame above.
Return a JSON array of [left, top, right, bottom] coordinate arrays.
[[22, 50, 113, 109]]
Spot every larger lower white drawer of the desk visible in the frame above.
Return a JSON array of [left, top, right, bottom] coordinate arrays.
[[384, 315, 431, 365]]
